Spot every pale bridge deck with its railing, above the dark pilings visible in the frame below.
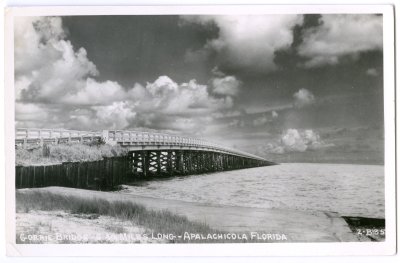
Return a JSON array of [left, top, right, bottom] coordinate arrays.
[[15, 128, 267, 161]]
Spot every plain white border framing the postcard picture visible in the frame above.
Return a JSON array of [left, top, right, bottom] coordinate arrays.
[[5, 5, 396, 256]]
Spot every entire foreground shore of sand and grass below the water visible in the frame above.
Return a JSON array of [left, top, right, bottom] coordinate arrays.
[[16, 187, 384, 243]]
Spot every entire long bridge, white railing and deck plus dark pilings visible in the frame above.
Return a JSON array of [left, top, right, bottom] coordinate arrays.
[[15, 128, 275, 177]]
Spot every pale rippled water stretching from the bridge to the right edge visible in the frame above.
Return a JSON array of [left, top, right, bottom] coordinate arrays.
[[124, 163, 385, 218]]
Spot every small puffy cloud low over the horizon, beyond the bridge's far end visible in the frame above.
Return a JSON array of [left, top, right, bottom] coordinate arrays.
[[264, 129, 333, 154]]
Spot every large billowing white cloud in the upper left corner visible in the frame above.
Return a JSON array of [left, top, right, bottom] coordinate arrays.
[[14, 17, 98, 102]]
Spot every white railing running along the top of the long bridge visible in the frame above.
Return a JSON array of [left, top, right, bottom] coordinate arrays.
[[15, 128, 266, 161]]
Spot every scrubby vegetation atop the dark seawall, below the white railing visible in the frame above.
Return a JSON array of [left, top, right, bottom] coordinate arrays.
[[15, 143, 127, 166]]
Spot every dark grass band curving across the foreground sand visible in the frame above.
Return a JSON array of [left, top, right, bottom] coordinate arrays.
[[16, 191, 223, 243]]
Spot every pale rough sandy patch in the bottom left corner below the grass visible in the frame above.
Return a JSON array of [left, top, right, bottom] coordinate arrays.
[[16, 210, 165, 244]]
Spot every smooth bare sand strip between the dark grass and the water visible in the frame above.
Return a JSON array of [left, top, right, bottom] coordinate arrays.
[[17, 187, 378, 242]]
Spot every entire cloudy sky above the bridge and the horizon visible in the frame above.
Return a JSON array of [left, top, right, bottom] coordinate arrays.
[[14, 14, 384, 163]]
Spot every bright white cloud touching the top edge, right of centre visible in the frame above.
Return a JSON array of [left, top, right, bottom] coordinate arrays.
[[181, 15, 303, 72]]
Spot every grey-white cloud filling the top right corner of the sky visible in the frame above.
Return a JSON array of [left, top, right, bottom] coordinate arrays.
[[298, 14, 383, 67]]
